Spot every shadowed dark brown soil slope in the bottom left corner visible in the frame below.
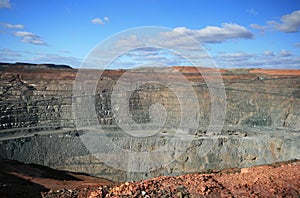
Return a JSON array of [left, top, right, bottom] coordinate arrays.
[[0, 160, 114, 198]]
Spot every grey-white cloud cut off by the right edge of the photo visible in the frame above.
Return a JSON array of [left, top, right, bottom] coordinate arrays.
[[267, 10, 300, 33]]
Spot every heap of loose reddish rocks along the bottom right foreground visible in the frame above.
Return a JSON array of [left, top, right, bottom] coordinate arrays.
[[43, 161, 300, 198]]
